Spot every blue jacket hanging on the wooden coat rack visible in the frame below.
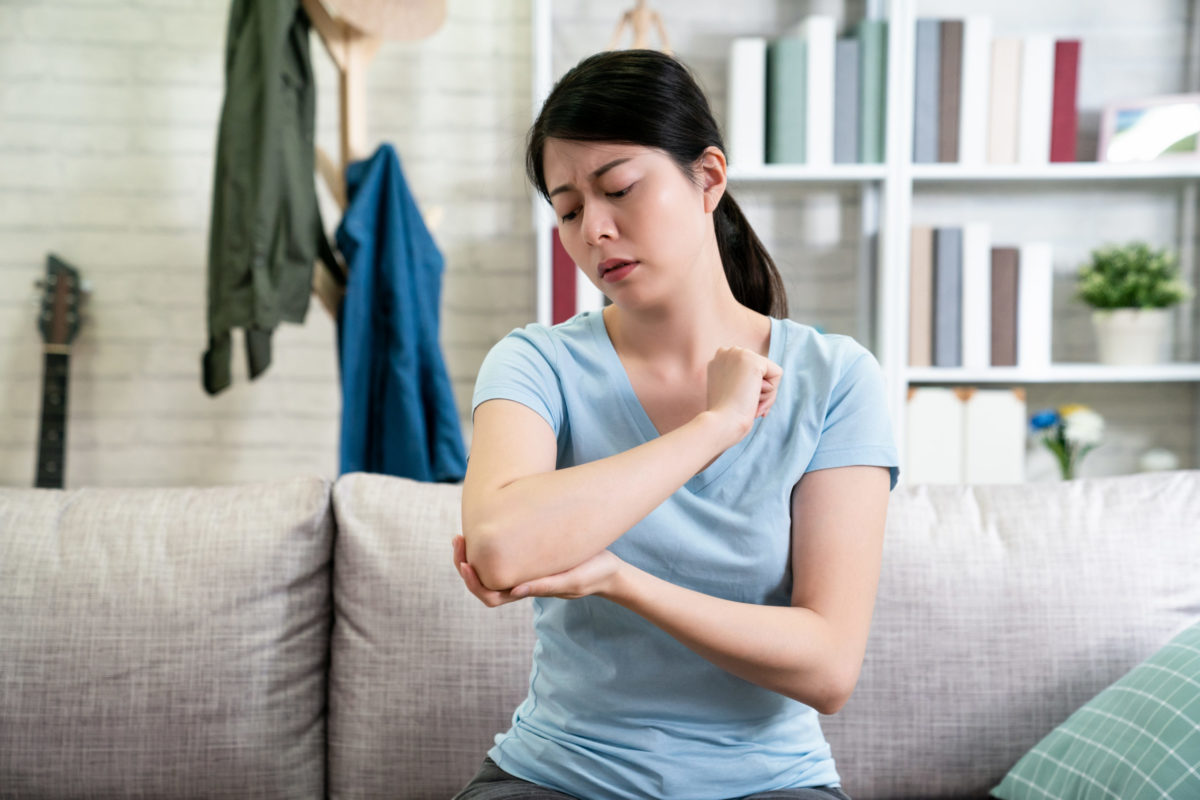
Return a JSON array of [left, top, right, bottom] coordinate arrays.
[[337, 144, 467, 481]]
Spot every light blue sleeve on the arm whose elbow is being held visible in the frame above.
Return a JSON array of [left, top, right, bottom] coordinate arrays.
[[470, 325, 563, 435]]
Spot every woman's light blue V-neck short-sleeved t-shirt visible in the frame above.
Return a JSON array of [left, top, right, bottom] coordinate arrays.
[[473, 312, 899, 800]]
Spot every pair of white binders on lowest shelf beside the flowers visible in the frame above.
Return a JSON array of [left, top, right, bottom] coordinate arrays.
[[902, 386, 1028, 486]]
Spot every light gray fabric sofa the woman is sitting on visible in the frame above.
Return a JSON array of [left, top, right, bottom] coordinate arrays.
[[0, 470, 1200, 800]]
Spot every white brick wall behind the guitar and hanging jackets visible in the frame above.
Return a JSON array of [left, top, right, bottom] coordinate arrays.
[[0, 0, 533, 486]]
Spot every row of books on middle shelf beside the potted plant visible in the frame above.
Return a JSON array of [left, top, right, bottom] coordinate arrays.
[[908, 222, 1054, 372]]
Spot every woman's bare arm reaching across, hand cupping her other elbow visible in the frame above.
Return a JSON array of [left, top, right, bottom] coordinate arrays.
[[455, 467, 890, 714]]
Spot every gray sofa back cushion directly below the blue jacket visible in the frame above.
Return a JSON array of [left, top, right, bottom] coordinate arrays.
[[329, 474, 533, 800]]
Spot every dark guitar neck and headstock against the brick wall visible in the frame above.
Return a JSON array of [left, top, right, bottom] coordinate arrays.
[[34, 253, 80, 489]]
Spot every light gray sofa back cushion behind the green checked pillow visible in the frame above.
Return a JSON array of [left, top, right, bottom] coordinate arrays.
[[822, 471, 1200, 800]]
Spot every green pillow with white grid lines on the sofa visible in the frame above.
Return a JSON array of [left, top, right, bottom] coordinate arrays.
[[991, 622, 1200, 800]]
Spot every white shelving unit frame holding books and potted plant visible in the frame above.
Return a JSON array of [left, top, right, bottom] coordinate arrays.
[[532, 0, 1200, 474]]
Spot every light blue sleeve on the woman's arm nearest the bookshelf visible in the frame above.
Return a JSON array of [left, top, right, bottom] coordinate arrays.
[[805, 349, 900, 491]]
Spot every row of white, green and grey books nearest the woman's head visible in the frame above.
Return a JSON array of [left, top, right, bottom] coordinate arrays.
[[725, 14, 888, 169]]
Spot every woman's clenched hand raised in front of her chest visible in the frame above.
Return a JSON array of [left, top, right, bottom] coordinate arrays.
[[708, 347, 784, 447]]
